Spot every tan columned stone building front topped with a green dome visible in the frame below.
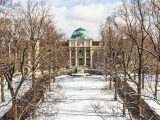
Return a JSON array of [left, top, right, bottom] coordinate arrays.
[[68, 28, 102, 68]]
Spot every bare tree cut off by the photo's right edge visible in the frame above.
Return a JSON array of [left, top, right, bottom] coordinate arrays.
[[144, 0, 160, 98]]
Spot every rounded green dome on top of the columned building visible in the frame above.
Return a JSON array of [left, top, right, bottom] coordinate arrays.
[[71, 28, 90, 39]]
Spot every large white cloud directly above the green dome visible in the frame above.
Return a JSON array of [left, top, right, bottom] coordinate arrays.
[[53, 3, 113, 38]]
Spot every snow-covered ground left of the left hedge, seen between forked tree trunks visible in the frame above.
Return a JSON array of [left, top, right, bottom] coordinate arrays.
[[0, 76, 31, 117]]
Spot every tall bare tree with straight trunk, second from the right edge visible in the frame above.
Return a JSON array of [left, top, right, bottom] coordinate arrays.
[[115, 0, 150, 120]]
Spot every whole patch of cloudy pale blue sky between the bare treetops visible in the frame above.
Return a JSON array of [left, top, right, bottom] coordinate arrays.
[[14, 0, 120, 39]]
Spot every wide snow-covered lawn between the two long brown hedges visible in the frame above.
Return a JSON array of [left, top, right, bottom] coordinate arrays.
[[36, 75, 127, 120]]
